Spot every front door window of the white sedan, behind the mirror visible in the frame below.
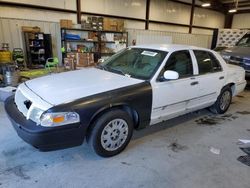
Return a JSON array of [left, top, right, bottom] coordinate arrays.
[[159, 50, 193, 78]]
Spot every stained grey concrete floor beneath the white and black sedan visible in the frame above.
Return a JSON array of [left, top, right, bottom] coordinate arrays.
[[0, 90, 250, 188]]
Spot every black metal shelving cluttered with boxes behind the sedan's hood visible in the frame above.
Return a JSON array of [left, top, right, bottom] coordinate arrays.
[[61, 28, 128, 69]]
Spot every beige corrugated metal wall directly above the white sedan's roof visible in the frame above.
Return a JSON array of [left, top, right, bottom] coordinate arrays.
[[128, 29, 212, 48]]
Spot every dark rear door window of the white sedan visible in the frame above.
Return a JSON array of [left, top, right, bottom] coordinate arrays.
[[194, 50, 222, 74]]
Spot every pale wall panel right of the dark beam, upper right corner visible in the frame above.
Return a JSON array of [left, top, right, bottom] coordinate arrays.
[[232, 13, 250, 29]]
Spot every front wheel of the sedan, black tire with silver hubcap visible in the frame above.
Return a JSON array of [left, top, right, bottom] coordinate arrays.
[[87, 109, 133, 157]]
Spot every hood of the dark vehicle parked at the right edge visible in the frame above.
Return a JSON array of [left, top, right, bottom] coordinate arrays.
[[221, 46, 250, 58]]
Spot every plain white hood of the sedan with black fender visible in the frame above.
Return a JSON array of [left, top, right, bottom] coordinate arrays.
[[25, 68, 143, 105]]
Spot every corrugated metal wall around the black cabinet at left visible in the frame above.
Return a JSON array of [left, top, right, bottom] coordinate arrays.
[[0, 18, 61, 60]]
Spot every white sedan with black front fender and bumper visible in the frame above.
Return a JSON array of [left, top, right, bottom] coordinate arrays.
[[5, 45, 246, 157]]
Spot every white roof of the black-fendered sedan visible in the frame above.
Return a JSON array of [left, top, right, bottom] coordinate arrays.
[[132, 44, 211, 52]]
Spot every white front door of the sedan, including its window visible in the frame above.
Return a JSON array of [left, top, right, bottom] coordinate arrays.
[[150, 50, 198, 124]]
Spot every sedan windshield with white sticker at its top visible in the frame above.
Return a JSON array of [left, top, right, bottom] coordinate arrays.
[[97, 48, 167, 80]]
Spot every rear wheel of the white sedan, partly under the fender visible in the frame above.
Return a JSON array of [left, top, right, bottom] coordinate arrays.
[[210, 86, 232, 114]]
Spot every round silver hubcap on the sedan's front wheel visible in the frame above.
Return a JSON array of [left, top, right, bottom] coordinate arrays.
[[101, 119, 128, 151]]
